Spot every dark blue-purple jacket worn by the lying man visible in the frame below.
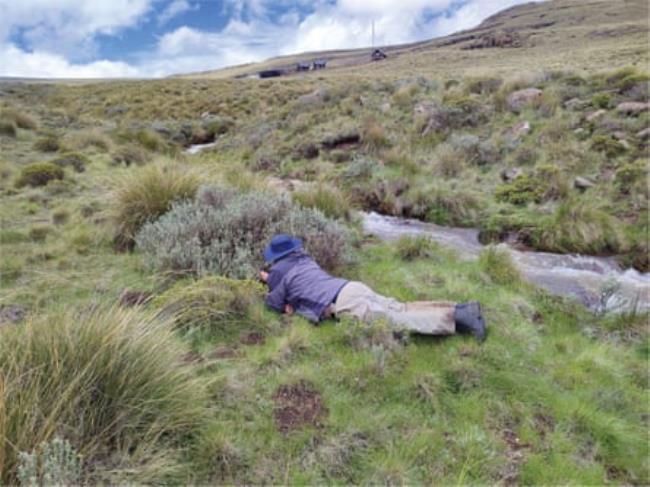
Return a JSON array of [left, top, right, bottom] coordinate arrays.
[[266, 250, 348, 323]]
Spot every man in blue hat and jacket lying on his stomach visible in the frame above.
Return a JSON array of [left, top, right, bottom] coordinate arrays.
[[260, 235, 486, 342]]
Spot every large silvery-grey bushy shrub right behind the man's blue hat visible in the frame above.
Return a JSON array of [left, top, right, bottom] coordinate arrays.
[[136, 187, 348, 277]]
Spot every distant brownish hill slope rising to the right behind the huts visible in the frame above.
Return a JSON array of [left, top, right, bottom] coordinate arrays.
[[181, 0, 649, 78]]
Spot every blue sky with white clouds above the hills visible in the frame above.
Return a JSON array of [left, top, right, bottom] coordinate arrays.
[[0, 0, 527, 78]]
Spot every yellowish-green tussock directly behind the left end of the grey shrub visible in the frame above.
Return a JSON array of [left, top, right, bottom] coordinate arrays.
[[112, 165, 200, 249]]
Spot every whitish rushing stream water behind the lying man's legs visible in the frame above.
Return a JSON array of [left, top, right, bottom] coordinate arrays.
[[363, 212, 650, 311]]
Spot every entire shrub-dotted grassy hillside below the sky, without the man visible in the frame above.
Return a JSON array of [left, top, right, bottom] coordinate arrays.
[[0, 1, 650, 486]]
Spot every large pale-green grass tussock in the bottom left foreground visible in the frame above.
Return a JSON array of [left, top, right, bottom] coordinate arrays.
[[0, 309, 207, 485]]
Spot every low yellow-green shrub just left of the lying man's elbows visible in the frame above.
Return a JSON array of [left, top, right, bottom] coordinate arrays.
[[152, 276, 264, 335]]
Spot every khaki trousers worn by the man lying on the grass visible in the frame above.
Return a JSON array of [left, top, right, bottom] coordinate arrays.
[[334, 281, 456, 335]]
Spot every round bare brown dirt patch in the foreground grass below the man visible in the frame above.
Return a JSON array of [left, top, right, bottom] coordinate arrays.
[[273, 380, 327, 434]]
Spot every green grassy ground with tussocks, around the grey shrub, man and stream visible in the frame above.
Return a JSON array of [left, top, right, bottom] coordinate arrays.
[[0, 37, 650, 485]]
